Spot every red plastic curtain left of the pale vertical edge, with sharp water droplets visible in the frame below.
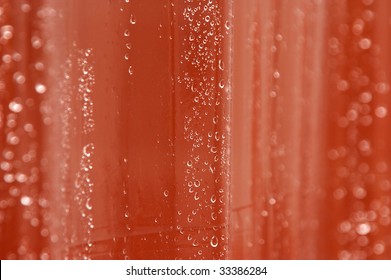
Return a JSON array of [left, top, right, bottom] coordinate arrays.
[[0, 0, 231, 259]]
